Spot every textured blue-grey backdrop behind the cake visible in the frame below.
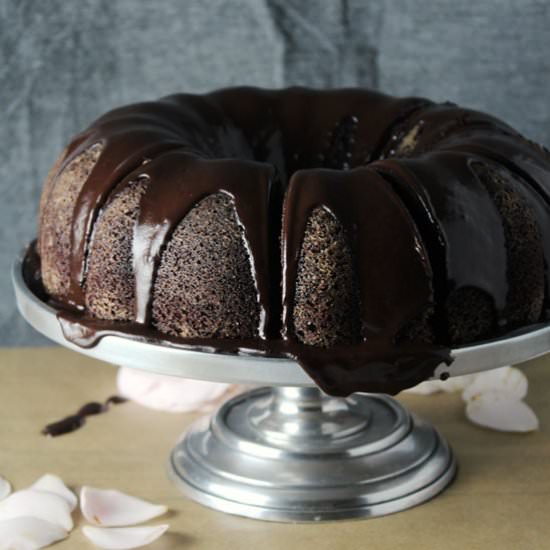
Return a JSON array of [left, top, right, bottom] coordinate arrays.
[[0, 0, 550, 345]]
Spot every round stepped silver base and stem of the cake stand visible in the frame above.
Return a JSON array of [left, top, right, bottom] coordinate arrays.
[[169, 387, 456, 522]]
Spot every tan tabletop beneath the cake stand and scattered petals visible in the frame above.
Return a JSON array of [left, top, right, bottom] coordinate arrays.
[[0, 348, 550, 550]]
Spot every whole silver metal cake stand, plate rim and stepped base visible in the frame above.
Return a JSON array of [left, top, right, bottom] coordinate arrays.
[[12, 254, 550, 522]]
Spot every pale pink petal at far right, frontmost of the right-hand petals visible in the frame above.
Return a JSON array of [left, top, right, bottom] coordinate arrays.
[[466, 392, 539, 432]]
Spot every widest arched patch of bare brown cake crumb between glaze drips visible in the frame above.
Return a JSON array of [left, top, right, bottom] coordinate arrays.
[[152, 193, 260, 338]]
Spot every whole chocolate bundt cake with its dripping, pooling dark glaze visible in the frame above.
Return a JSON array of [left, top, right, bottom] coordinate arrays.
[[36, 88, 550, 395]]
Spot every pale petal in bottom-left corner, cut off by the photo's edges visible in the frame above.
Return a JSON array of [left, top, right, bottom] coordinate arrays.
[[0, 517, 68, 550]]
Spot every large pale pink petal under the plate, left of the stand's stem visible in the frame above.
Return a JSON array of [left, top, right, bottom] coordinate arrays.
[[117, 367, 231, 413]]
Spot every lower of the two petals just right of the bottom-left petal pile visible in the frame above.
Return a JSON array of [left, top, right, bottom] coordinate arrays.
[[82, 525, 169, 550]]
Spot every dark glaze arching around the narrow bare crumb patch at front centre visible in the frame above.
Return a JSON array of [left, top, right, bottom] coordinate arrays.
[[283, 168, 432, 344]]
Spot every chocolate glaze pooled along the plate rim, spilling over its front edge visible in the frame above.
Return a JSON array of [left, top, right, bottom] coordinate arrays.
[[58, 311, 452, 396]]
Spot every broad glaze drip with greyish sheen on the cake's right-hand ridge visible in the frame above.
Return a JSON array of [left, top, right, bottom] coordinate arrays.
[[373, 152, 509, 327]]
